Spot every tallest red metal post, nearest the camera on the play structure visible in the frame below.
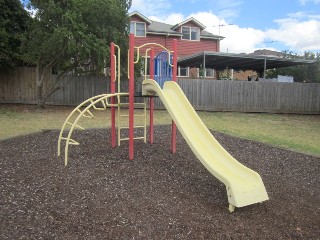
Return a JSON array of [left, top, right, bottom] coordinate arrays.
[[128, 33, 134, 160]]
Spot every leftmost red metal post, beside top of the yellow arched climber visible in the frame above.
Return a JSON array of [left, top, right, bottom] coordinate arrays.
[[110, 42, 116, 147]]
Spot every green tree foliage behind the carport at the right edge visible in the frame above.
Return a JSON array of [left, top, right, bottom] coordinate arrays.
[[267, 51, 320, 82]]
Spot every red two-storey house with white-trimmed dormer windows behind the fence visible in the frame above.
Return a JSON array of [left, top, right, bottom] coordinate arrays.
[[129, 12, 224, 78]]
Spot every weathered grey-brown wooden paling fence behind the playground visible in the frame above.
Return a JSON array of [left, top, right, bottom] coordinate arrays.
[[0, 68, 320, 114]]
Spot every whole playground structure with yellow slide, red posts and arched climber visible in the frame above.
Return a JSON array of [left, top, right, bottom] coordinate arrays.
[[58, 35, 268, 212]]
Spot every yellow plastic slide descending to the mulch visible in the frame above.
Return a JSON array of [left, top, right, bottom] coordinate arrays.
[[142, 80, 269, 212]]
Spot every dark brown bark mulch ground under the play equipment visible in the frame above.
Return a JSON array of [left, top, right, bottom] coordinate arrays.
[[0, 126, 320, 239]]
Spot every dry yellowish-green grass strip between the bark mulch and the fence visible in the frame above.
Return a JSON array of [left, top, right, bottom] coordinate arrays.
[[0, 105, 320, 156]]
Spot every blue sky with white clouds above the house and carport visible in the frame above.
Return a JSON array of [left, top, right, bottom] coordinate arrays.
[[129, 0, 320, 53]]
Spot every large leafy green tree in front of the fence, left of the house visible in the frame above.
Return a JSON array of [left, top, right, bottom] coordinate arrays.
[[24, 0, 131, 106]]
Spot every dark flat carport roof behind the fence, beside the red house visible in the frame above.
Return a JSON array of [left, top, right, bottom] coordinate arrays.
[[178, 51, 315, 72]]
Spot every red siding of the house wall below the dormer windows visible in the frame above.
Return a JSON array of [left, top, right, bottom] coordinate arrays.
[[134, 34, 218, 57]]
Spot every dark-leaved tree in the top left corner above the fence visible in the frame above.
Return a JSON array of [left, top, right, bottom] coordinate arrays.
[[0, 0, 30, 70]]
